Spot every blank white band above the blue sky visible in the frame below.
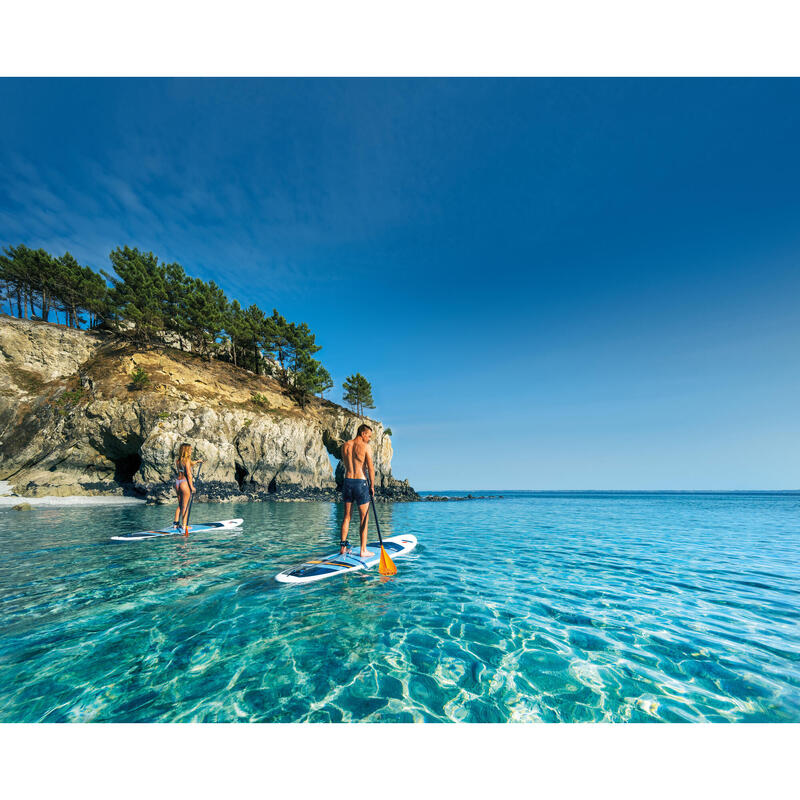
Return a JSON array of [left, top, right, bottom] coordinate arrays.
[[0, 0, 800, 76]]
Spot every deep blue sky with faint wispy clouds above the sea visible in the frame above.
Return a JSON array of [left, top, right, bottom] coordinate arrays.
[[0, 79, 800, 489]]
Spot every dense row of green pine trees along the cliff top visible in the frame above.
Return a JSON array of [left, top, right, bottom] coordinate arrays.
[[0, 244, 333, 407]]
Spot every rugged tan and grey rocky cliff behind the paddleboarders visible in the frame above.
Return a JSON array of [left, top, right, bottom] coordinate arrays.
[[0, 315, 418, 502]]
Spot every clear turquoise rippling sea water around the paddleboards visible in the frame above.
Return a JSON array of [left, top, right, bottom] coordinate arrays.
[[0, 492, 800, 722]]
